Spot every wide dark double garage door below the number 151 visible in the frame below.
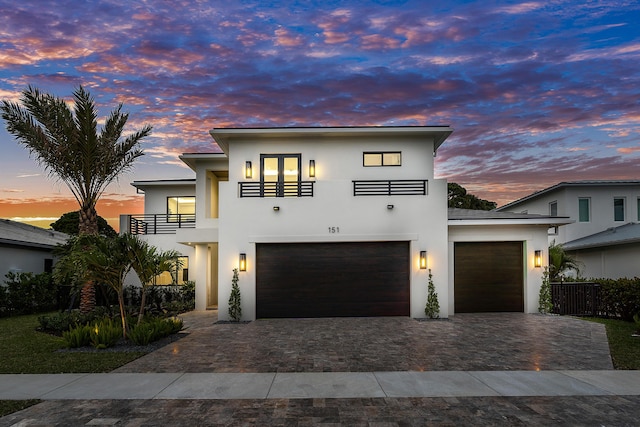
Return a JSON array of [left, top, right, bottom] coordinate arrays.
[[256, 242, 410, 318]]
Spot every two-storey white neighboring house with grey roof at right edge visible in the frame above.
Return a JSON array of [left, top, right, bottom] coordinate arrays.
[[497, 180, 640, 279]]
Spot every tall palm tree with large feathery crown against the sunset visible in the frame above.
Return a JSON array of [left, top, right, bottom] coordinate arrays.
[[0, 86, 151, 311]]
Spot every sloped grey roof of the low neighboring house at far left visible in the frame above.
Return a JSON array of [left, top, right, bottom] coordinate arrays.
[[0, 219, 69, 249]]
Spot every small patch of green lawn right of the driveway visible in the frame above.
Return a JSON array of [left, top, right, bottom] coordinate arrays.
[[587, 317, 640, 369]]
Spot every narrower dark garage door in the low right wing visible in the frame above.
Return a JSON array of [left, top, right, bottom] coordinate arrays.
[[454, 242, 524, 313]]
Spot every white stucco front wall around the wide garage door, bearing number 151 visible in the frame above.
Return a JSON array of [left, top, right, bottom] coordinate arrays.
[[218, 135, 449, 320]]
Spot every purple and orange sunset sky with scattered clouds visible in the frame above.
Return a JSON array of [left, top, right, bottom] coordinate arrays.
[[0, 0, 640, 231]]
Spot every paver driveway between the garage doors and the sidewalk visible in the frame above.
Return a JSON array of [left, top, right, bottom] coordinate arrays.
[[115, 312, 613, 372]]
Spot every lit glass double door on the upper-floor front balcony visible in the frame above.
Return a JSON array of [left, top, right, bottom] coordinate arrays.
[[260, 154, 301, 197]]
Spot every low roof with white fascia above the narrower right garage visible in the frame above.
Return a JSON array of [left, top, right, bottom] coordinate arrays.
[[449, 208, 575, 226]]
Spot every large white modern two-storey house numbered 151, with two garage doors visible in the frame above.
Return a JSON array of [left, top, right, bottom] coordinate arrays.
[[121, 126, 567, 320]]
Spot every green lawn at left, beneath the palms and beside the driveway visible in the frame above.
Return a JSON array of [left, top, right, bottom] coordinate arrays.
[[0, 314, 144, 417]]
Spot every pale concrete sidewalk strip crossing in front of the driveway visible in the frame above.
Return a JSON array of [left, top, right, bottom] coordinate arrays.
[[0, 370, 640, 400]]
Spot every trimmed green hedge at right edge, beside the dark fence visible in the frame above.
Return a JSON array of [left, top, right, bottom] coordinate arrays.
[[593, 277, 640, 321]]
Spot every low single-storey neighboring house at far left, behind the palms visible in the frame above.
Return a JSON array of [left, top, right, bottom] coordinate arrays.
[[0, 219, 69, 284]]
